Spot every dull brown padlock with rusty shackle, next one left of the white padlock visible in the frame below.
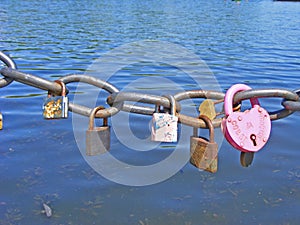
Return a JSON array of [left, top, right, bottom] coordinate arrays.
[[86, 106, 110, 156]]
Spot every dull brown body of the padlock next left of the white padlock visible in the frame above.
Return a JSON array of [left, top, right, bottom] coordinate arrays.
[[86, 126, 110, 156]]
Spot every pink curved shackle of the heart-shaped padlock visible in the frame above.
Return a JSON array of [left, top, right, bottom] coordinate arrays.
[[224, 84, 259, 116]]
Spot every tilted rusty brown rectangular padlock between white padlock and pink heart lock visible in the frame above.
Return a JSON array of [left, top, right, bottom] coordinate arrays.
[[190, 115, 218, 173]]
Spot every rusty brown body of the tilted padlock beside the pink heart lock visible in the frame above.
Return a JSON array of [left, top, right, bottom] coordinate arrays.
[[190, 136, 218, 173]]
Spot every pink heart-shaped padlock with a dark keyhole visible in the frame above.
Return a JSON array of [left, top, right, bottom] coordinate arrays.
[[222, 84, 271, 152]]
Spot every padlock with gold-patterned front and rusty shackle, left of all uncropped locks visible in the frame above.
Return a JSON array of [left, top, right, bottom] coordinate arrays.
[[43, 80, 69, 119]]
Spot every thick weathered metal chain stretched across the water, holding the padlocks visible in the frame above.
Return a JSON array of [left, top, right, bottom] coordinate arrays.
[[0, 51, 300, 128]]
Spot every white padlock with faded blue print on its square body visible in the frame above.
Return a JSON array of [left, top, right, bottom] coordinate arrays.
[[151, 95, 178, 142]]
